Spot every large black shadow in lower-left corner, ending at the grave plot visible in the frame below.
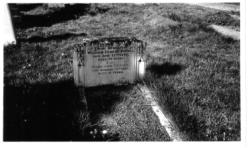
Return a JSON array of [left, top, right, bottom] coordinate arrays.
[[4, 81, 85, 141]]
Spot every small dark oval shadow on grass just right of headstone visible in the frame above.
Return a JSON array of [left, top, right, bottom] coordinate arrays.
[[147, 62, 184, 77]]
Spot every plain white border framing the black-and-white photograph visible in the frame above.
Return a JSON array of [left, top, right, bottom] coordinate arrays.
[[0, 0, 248, 148]]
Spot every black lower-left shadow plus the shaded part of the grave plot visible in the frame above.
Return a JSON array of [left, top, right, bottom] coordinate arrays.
[[4, 80, 125, 141]]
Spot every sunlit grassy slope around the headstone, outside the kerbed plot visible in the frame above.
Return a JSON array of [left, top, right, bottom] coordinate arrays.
[[4, 4, 240, 140]]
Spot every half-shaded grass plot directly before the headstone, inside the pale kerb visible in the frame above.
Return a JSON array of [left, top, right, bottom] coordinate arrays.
[[83, 85, 170, 141]]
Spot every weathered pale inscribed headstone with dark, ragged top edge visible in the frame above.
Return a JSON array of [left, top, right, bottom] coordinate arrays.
[[73, 37, 145, 87]]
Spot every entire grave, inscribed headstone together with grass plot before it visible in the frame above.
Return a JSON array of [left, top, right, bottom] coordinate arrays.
[[73, 37, 178, 141]]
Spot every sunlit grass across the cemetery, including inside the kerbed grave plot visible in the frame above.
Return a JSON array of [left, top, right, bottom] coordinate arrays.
[[4, 4, 240, 141]]
